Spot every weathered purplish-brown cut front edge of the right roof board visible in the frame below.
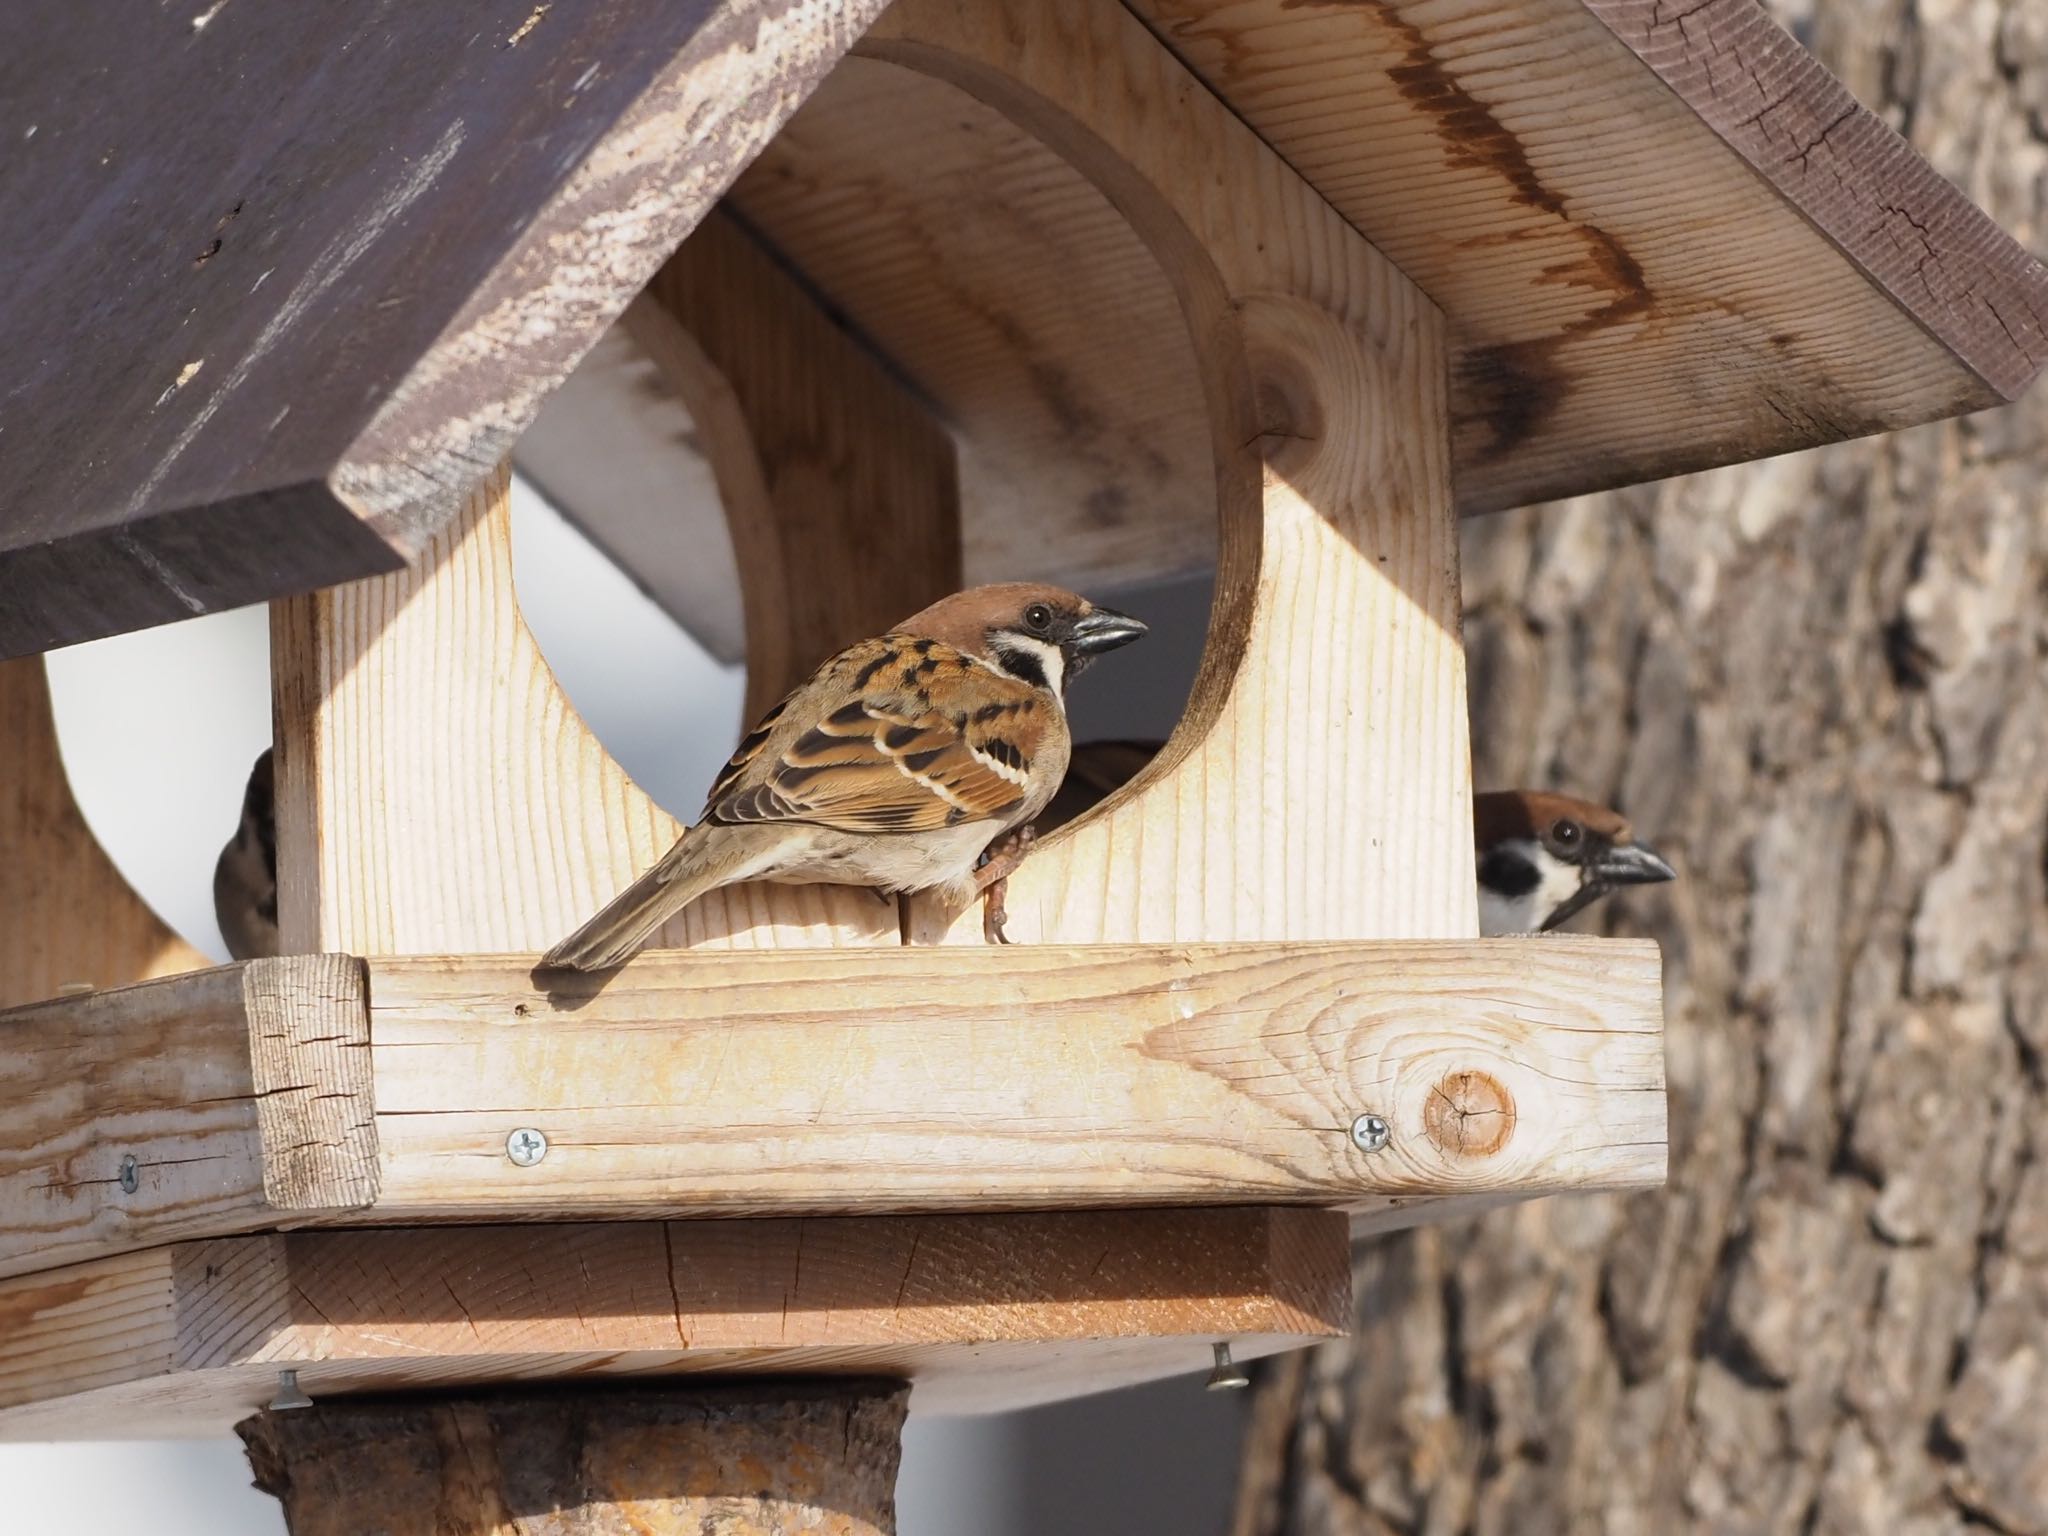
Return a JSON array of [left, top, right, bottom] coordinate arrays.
[[1581, 0, 2048, 399]]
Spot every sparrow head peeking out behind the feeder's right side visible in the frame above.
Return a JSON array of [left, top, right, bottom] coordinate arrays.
[[1473, 791, 1677, 936]]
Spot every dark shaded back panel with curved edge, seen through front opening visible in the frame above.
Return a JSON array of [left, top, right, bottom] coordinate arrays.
[[625, 215, 961, 721]]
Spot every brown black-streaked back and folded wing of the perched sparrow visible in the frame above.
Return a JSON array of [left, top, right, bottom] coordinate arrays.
[[705, 635, 1044, 831]]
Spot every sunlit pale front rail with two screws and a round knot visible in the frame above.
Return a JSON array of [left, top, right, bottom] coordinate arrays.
[[371, 938, 1665, 1223]]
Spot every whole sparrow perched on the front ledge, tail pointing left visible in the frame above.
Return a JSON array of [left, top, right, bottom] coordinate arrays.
[[541, 582, 1145, 971]]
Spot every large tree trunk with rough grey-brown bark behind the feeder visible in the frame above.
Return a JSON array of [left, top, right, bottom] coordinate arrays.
[[1235, 0, 2048, 1536]]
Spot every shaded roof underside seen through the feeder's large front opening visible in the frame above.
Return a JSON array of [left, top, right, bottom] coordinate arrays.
[[729, 55, 1217, 592]]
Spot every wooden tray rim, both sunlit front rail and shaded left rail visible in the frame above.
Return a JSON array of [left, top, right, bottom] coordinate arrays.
[[0, 938, 1665, 1274]]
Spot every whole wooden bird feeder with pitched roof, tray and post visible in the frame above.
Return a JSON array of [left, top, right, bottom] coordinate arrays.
[[0, 0, 2048, 1532]]
